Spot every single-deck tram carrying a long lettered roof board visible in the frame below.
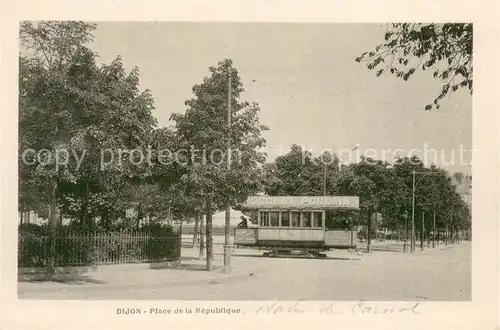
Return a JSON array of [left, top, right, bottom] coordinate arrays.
[[234, 196, 359, 255]]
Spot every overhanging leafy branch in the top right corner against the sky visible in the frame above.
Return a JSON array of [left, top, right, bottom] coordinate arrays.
[[356, 23, 473, 110]]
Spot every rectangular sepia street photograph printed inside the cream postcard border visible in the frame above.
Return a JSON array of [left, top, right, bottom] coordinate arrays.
[[17, 20, 476, 304]]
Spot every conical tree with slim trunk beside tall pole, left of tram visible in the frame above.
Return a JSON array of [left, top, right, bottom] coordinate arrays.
[[172, 60, 267, 271]]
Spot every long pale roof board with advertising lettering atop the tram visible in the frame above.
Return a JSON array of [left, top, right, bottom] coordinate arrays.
[[241, 196, 359, 210]]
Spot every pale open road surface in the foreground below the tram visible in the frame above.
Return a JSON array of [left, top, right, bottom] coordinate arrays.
[[19, 242, 471, 301]]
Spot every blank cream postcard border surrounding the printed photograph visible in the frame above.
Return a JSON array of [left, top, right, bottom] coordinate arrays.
[[0, 1, 500, 329]]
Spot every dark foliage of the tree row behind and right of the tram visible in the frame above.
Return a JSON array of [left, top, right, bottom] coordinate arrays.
[[263, 145, 470, 235]]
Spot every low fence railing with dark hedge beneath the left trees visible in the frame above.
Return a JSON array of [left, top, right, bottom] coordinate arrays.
[[18, 232, 182, 267]]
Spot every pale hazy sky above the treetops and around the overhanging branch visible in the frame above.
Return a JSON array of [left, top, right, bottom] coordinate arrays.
[[90, 22, 472, 173]]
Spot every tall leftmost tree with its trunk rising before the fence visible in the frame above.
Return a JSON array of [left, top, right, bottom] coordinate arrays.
[[19, 22, 99, 279]]
